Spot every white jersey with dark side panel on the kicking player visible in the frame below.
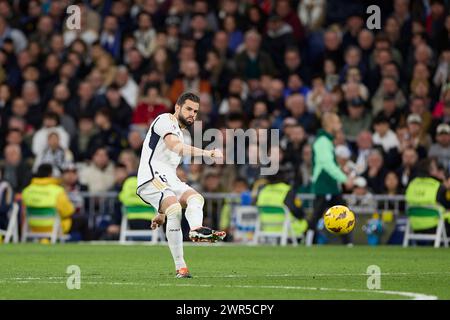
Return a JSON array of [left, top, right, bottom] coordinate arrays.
[[137, 113, 184, 189]]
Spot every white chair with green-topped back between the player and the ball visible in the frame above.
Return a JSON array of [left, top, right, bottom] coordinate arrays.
[[254, 206, 303, 246]]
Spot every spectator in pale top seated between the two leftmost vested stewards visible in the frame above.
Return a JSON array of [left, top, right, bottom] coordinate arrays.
[[80, 147, 114, 192]]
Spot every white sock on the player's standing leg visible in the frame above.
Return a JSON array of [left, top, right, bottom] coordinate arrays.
[[166, 203, 186, 270]]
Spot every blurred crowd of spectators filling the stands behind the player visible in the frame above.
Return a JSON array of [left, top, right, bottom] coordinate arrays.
[[0, 0, 450, 203]]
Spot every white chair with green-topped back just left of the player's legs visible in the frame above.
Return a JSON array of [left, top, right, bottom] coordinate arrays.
[[119, 206, 164, 244]]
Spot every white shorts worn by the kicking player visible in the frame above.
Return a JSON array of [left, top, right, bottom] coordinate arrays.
[[137, 167, 194, 212]]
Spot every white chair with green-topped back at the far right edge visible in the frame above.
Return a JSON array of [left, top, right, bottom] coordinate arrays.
[[403, 206, 448, 248]]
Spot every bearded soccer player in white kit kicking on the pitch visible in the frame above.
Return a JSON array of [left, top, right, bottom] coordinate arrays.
[[136, 92, 225, 278]]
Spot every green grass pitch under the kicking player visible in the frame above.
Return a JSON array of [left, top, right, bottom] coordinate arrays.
[[0, 244, 450, 300]]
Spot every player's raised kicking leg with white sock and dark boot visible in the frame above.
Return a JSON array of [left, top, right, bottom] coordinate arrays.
[[179, 188, 226, 242]]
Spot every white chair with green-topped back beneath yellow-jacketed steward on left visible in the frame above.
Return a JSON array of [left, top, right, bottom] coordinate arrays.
[[21, 207, 68, 244]]
